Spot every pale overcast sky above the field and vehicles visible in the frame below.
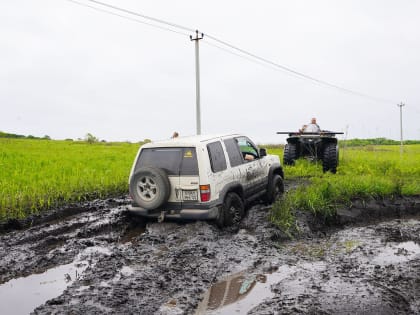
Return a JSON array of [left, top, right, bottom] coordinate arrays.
[[0, 0, 420, 143]]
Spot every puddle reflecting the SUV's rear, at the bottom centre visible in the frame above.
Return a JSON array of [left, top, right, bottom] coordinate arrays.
[[195, 266, 296, 315]]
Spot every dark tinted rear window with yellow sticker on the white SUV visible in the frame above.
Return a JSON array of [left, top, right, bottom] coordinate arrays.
[[136, 148, 198, 175]]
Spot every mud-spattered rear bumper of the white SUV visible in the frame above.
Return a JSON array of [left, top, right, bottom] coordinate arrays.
[[127, 205, 219, 220]]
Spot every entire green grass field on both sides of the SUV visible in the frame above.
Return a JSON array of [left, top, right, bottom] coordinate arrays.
[[0, 138, 420, 230]]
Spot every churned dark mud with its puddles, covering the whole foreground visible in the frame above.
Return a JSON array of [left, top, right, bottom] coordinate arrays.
[[0, 183, 420, 314]]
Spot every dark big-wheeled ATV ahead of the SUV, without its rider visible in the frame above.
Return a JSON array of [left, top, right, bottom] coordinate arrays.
[[277, 131, 343, 174]]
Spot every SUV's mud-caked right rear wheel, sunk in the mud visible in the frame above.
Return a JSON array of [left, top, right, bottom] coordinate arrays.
[[216, 193, 245, 228]]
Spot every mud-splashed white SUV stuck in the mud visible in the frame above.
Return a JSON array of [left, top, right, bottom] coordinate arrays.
[[129, 134, 284, 226]]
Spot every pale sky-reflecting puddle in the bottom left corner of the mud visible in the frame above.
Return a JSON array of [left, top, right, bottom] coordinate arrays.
[[0, 247, 111, 315]]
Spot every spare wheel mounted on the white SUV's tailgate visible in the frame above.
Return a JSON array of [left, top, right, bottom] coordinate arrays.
[[130, 167, 170, 210]]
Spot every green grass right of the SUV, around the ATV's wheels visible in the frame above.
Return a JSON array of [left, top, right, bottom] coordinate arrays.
[[269, 145, 420, 231]]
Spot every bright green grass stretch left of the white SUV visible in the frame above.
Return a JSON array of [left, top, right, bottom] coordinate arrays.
[[0, 139, 139, 220]]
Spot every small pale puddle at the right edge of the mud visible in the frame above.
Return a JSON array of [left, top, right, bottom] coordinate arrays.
[[372, 241, 420, 266]]
